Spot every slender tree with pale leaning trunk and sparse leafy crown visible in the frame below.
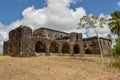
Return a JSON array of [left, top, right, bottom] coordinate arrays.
[[78, 15, 106, 63]]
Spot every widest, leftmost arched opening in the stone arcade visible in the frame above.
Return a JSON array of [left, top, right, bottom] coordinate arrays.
[[35, 41, 46, 53]]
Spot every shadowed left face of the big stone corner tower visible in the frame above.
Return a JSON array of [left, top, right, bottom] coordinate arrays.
[[4, 27, 22, 56]]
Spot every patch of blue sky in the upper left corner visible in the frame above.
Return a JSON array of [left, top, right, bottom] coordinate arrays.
[[0, 0, 46, 25]]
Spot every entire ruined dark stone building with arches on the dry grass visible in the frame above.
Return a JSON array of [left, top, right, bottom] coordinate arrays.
[[3, 25, 111, 57]]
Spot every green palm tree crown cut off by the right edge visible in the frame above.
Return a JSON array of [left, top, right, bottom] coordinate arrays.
[[108, 11, 120, 36]]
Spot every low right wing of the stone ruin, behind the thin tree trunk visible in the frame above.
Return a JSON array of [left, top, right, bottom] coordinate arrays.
[[84, 37, 111, 55]]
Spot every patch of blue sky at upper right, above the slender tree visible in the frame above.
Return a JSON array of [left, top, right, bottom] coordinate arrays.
[[71, 0, 120, 15]]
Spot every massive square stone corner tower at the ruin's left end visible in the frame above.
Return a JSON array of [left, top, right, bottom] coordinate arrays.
[[3, 25, 34, 56]]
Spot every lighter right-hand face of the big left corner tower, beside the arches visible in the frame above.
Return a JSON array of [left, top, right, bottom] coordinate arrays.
[[20, 26, 34, 56]]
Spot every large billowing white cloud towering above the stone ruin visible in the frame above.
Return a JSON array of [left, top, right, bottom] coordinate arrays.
[[22, 0, 86, 31]]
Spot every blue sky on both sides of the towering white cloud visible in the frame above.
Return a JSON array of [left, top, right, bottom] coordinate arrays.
[[0, 0, 120, 25]]
